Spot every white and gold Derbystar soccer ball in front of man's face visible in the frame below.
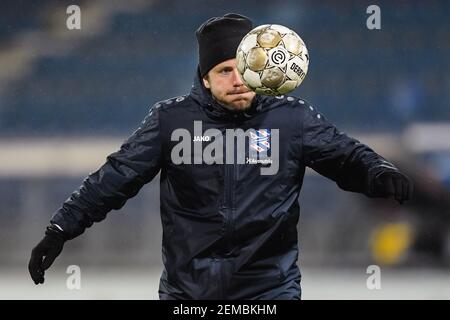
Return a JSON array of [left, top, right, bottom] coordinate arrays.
[[236, 24, 309, 96]]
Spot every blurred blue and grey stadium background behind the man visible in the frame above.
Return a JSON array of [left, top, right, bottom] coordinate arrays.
[[0, 0, 450, 299]]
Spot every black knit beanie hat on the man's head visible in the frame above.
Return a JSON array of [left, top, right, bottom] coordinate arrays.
[[195, 13, 252, 77]]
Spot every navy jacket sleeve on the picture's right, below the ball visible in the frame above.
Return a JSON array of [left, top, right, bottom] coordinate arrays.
[[302, 102, 398, 197]]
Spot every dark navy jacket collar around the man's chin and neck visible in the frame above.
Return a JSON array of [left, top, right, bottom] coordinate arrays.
[[190, 68, 263, 121]]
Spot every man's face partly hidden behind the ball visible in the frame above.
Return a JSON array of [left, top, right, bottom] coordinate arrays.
[[203, 59, 255, 110]]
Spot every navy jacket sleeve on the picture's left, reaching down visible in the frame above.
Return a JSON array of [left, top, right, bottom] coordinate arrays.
[[50, 107, 161, 239]]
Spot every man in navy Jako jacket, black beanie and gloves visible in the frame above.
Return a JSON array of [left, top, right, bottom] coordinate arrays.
[[29, 14, 411, 299]]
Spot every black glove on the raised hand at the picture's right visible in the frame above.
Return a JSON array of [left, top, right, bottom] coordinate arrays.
[[374, 170, 413, 204]]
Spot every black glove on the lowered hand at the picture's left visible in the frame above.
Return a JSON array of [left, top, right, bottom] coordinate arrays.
[[28, 225, 66, 284]]
